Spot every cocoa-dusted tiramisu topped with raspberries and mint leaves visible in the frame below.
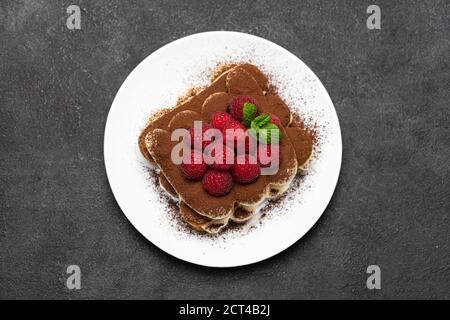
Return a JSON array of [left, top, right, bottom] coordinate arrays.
[[139, 64, 315, 233]]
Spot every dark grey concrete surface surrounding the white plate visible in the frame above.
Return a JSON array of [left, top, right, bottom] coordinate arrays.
[[0, 0, 450, 299]]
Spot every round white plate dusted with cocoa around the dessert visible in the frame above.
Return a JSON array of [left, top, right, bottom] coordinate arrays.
[[104, 31, 342, 267]]
